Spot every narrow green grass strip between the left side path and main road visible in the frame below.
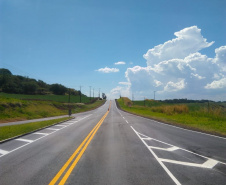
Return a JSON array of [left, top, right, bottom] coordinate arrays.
[[0, 117, 70, 141]]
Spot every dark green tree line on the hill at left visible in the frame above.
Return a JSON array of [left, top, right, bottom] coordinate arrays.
[[0, 68, 81, 95]]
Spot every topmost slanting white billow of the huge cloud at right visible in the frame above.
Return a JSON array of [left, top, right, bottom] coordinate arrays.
[[143, 26, 214, 66]]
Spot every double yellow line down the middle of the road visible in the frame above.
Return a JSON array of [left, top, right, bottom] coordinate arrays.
[[49, 102, 111, 185]]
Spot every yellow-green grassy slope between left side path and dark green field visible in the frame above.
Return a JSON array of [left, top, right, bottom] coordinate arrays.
[[0, 96, 105, 123]]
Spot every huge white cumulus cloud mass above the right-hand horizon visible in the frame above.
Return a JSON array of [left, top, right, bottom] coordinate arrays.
[[111, 26, 226, 99]]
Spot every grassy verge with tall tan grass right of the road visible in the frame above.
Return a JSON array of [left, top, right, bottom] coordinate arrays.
[[117, 98, 226, 136]]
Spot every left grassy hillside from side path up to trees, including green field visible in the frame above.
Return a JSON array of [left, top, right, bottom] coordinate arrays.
[[0, 93, 105, 123]]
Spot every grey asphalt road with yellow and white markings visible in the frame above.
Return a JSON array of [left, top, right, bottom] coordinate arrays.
[[0, 101, 226, 185]]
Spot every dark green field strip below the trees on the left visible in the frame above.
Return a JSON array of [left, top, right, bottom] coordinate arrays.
[[0, 93, 90, 103]]
